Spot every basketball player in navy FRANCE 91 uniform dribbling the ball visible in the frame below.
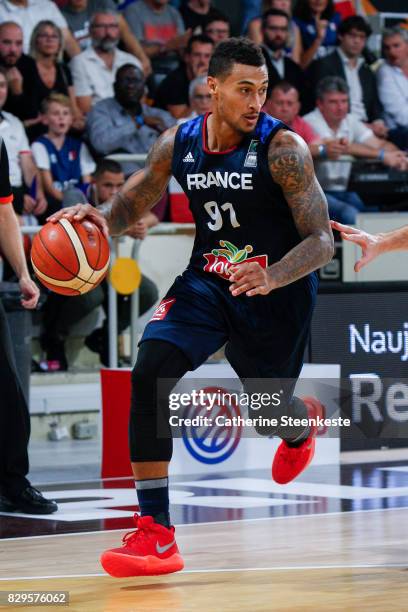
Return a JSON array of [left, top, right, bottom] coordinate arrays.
[[51, 38, 333, 576]]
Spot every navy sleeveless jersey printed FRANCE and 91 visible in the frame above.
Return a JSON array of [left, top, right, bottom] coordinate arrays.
[[172, 113, 301, 279]]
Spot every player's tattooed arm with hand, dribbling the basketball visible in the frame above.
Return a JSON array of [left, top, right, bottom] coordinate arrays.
[[48, 126, 177, 236]]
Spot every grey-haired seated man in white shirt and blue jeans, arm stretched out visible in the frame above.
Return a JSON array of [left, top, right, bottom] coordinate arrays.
[[304, 77, 408, 225]]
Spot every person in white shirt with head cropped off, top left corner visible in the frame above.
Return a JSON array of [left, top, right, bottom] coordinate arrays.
[[0, 0, 80, 57]]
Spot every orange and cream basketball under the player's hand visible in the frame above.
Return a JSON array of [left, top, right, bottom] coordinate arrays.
[[31, 219, 109, 295]]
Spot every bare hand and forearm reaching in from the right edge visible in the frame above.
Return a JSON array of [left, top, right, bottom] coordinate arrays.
[[330, 221, 408, 272]]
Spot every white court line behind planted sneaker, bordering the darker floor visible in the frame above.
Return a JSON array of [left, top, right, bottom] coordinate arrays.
[[0, 506, 408, 542]]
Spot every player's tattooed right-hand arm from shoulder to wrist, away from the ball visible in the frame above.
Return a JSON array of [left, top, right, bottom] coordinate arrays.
[[268, 131, 333, 287]]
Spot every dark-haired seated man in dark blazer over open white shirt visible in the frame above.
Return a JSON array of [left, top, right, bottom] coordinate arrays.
[[310, 16, 388, 138]]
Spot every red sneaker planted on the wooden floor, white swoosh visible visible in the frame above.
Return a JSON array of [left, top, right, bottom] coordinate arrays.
[[100, 514, 184, 578]]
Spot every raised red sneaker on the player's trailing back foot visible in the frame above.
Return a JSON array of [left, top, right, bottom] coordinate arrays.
[[272, 397, 325, 484]]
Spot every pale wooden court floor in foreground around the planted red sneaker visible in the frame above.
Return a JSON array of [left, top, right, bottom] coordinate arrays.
[[0, 508, 408, 612]]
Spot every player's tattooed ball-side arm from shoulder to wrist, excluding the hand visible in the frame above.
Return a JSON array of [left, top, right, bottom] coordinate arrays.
[[99, 128, 177, 236]]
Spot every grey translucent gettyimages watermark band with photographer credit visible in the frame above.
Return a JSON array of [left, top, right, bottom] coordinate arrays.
[[157, 374, 408, 441]]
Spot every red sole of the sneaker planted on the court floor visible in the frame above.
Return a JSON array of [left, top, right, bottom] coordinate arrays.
[[100, 551, 184, 578]]
